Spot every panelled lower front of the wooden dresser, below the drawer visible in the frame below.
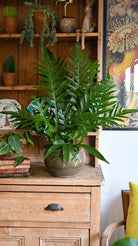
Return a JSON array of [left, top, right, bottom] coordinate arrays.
[[0, 228, 89, 246]]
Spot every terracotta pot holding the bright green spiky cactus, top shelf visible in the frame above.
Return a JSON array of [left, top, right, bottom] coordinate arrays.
[[4, 17, 17, 34]]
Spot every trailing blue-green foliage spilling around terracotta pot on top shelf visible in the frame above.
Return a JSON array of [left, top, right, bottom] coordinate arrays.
[[20, 0, 57, 56]]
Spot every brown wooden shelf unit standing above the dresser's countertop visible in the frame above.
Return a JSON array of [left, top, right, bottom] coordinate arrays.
[[0, 0, 102, 166]]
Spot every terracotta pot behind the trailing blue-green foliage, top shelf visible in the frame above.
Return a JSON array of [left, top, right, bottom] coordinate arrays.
[[33, 10, 50, 33]]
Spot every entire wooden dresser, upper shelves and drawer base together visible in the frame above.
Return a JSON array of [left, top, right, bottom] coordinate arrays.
[[0, 0, 103, 246]]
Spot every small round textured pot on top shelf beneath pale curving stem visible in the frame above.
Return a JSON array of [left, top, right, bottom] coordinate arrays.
[[59, 17, 76, 33]]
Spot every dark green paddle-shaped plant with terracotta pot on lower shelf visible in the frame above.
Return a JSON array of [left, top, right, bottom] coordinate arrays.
[[3, 55, 16, 86]]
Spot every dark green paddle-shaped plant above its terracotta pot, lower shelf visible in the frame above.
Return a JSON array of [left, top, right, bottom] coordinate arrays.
[[3, 55, 16, 73]]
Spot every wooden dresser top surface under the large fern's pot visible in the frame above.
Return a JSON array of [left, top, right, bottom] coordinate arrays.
[[0, 163, 104, 186]]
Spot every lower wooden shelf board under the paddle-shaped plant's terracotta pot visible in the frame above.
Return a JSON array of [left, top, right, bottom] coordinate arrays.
[[0, 85, 38, 91]]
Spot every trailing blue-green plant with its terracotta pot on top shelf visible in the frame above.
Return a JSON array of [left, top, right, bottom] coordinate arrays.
[[20, 0, 57, 55]]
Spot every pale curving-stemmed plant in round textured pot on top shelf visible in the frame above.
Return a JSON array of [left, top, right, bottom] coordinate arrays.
[[56, 0, 76, 33]]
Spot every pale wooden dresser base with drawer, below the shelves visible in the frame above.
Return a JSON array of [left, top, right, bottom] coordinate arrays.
[[0, 164, 104, 246]]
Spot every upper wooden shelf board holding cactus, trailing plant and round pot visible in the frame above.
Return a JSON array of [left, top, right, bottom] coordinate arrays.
[[0, 32, 101, 38]]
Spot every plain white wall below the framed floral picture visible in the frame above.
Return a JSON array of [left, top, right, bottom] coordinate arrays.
[[99, 130, 138, 243]]
